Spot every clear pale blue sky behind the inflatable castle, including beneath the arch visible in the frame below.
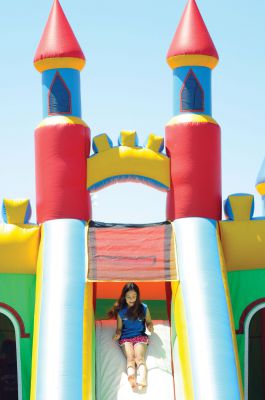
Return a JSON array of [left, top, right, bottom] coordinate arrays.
[[0, 0, 265, 223]]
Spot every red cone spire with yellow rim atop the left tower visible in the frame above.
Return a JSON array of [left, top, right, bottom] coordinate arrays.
[[34, 0, 85, 72]]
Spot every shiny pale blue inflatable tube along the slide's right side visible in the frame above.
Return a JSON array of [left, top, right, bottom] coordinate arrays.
[[173, 218, 240, 400]]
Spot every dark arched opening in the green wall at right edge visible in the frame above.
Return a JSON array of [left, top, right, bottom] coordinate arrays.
[[248, 308, 265, 400]]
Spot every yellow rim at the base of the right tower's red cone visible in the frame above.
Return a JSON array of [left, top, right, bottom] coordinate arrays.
[[167, 54, 219, 69]]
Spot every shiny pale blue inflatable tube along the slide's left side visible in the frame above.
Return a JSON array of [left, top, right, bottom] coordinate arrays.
[[36, 219, 85, 400]]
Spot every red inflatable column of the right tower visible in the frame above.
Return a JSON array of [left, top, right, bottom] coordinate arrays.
[[166, 118, 221, 220]]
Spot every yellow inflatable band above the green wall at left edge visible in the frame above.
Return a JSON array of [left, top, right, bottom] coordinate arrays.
[[0, 224, 40, 274]]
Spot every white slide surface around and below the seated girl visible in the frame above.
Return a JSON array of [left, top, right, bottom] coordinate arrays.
[[96, 320, 174, 400]]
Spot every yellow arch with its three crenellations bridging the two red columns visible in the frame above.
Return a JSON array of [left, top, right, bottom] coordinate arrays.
[[87, 131, 170, 191]]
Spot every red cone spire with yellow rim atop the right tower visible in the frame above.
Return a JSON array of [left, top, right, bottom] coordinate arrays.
[[167, 0, 219, 68]]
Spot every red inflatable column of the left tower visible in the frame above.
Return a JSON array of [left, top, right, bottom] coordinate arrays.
[[35, 118, 91, 223]]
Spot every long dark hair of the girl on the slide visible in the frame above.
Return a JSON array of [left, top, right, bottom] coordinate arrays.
[[107, 282, 144, 319]]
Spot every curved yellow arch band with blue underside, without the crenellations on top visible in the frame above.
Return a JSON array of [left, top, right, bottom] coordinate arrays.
[[87, 146, 170, 190]]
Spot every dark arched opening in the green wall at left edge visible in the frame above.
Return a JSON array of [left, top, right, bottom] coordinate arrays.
[[0, 313, 18, 400]]
